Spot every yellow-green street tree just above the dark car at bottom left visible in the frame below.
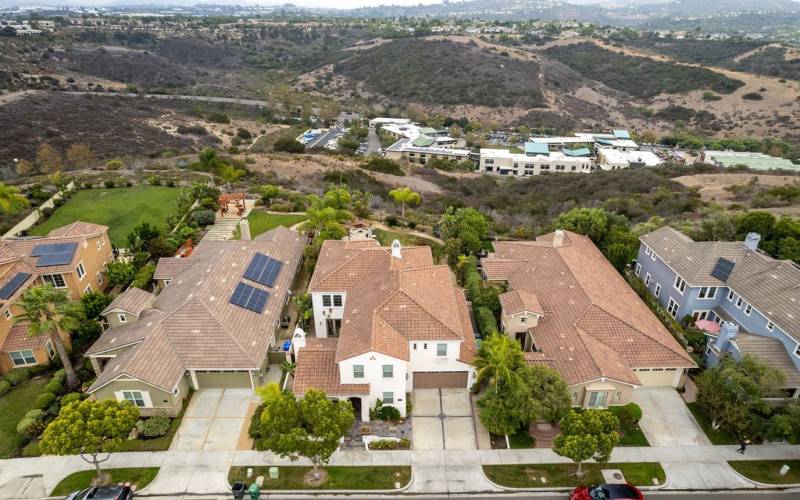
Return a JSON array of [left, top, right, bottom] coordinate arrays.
[[39, 399, 139, 479]]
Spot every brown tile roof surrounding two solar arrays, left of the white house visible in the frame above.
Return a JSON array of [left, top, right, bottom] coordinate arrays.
[[89, 227, 306, 392]]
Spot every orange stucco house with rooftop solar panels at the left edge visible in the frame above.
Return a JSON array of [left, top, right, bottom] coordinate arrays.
[[0, 222, 113, 373]]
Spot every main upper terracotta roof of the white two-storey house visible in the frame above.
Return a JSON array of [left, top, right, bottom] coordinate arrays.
[[309, 241, 475, 363]]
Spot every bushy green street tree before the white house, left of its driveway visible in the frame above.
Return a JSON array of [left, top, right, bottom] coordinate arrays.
[[259, 383, 355, 478]]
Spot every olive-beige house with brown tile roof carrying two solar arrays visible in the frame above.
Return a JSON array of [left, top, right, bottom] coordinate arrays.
[[86, 227, 306, 415]]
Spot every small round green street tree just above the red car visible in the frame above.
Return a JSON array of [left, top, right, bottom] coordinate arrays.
[[553, 409, 619, 477]]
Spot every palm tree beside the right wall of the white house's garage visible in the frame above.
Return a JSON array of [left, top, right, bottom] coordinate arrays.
[[475, 333, 524, 390]]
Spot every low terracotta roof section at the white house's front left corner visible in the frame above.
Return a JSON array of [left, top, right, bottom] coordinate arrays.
[[292, 338, 369, 396]]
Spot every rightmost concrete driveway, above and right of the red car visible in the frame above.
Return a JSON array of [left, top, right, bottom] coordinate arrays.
[[632, 387, 711, 446]]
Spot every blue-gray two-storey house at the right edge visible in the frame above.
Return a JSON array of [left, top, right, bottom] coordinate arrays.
[[635, 227, 800, 398]]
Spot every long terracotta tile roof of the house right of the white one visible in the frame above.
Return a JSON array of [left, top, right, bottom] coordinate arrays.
[[483, 231, 695, 385]]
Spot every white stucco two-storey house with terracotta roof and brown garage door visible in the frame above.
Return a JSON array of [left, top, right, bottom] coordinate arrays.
[[293, 240, 476, 420]]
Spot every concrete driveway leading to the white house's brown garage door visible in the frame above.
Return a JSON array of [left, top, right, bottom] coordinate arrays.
[[411, 389, 477, 450]]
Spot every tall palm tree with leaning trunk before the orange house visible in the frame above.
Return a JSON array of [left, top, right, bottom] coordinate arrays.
[[14, 285, 80, 389]]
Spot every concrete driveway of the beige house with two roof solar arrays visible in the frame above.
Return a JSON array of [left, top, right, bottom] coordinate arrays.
[[170, 389, 258, 451]]
